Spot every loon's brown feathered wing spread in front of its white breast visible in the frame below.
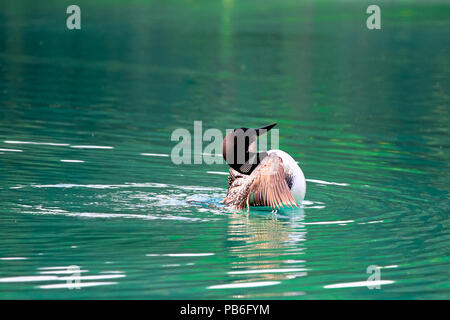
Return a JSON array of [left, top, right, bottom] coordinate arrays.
[[247, 154, 298, 209]]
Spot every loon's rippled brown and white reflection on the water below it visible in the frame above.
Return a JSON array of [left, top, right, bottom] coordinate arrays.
[[218, 209, 308, 289]]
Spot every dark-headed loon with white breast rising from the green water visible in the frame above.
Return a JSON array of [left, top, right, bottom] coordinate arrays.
[[222, 123, 306, 211]]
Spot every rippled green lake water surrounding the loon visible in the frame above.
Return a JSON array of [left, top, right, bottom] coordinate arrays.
[[0, 0, 450, 299]]
